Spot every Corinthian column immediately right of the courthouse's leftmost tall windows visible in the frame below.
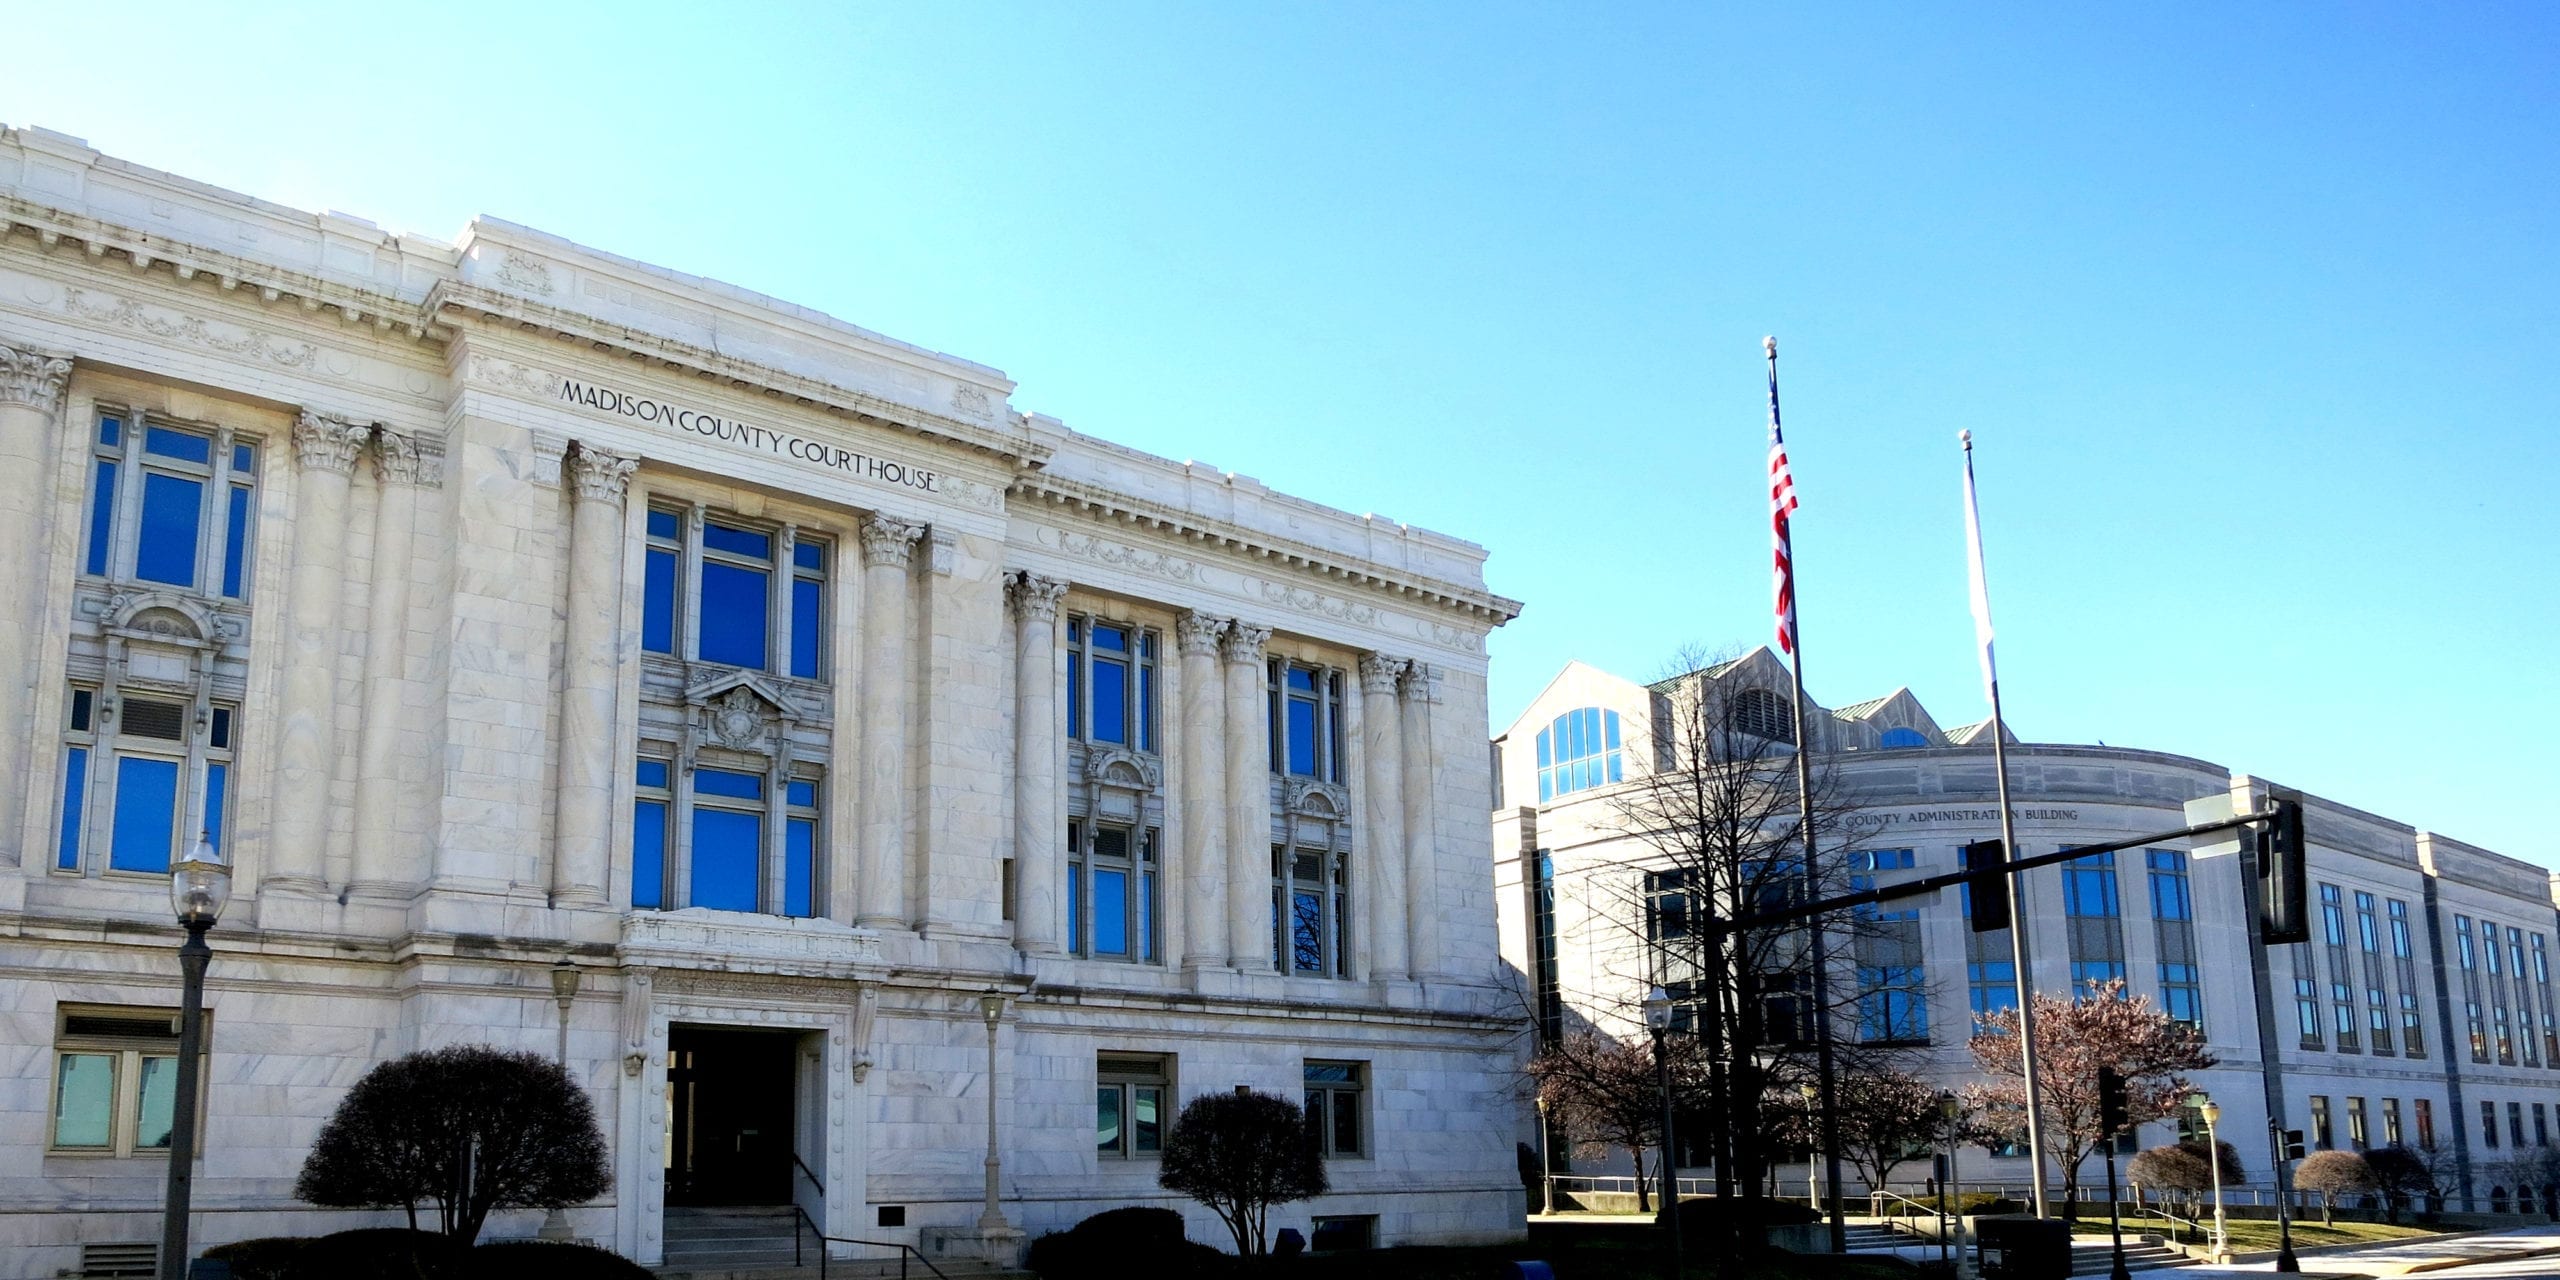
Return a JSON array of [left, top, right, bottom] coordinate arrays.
[[266, 410, 371, 893]]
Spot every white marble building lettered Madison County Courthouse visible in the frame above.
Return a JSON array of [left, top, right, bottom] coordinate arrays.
[[0, 128, 1523, 1275]]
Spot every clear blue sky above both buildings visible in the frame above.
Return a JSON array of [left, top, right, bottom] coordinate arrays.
[[0, 3, 2560, 863]]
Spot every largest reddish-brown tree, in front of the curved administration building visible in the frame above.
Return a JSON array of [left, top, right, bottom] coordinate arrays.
[[1964, 978, 2217, 1216]]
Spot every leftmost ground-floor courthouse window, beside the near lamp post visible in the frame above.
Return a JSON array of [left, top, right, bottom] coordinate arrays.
[[49, 1004, 194, 1155]]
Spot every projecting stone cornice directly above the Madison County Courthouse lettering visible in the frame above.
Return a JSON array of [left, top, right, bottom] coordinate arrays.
[[428, 279, 1050, 468]]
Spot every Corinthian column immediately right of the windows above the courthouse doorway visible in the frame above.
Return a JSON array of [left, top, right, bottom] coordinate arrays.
[[855, 515, 924, 927]]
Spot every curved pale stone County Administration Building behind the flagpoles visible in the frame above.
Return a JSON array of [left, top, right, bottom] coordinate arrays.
[[1492, 650, 2560, 1211]]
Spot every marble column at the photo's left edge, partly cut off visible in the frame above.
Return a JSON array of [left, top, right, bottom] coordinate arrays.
[[0, 346, 72, 860]]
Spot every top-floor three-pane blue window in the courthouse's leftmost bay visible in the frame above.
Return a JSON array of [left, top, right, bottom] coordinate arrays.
[[82, 412, 259, 599]]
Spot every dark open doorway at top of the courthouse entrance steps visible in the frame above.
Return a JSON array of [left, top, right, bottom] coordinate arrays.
[[666, 1027, 799, 1206]]
